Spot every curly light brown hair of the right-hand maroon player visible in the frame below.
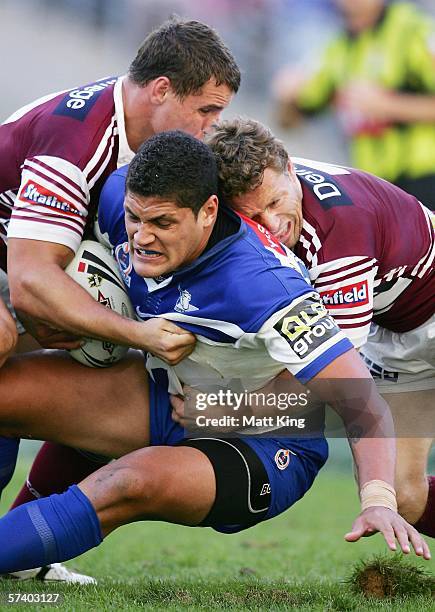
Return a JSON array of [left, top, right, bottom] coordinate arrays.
[[205, 117, 289, 204]]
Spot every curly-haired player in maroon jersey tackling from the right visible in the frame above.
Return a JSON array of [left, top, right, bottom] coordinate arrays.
[[207, 119, 435, 537]]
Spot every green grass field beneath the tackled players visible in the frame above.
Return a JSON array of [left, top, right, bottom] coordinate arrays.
[[0, 450, 435, 611]]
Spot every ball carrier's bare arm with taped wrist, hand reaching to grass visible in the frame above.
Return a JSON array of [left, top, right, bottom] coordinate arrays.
[[313, 350, 429, 558]]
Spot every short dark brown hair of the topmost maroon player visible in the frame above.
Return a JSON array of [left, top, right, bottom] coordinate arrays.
[[128, 18, 240, 98]]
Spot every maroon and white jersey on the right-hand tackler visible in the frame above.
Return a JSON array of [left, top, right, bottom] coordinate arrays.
[[292, 158, 435, 347]]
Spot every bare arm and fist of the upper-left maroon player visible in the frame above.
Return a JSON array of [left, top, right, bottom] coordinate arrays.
[[8, 238, 195, 363]]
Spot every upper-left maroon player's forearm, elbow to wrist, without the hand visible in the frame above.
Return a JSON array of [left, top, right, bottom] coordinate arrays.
[[10, 264, 143, 348]]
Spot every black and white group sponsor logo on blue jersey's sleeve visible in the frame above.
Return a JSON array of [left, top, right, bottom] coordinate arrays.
[[274, 299, 339, 359]]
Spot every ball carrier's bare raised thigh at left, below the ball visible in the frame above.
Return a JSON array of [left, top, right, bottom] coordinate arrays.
[[0, 351, 149, 457]]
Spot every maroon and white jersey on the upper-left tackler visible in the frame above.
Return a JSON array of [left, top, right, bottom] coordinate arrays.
[[0, 77, 133, 270]]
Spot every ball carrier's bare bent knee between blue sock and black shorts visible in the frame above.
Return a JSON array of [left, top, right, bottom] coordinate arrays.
[[80, 446, 216, 534]]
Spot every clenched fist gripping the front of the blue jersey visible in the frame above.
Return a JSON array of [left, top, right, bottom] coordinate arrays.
[[141, 318, 196, 365]]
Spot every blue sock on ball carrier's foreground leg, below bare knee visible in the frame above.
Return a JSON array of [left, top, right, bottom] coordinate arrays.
[[0, 485, 102, 574]]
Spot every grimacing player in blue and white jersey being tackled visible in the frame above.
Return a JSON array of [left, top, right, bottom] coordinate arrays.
[[0, 132, 430, 572]]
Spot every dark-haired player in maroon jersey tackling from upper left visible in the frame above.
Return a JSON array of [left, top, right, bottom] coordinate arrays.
[[0, 20, 240, 579]]
